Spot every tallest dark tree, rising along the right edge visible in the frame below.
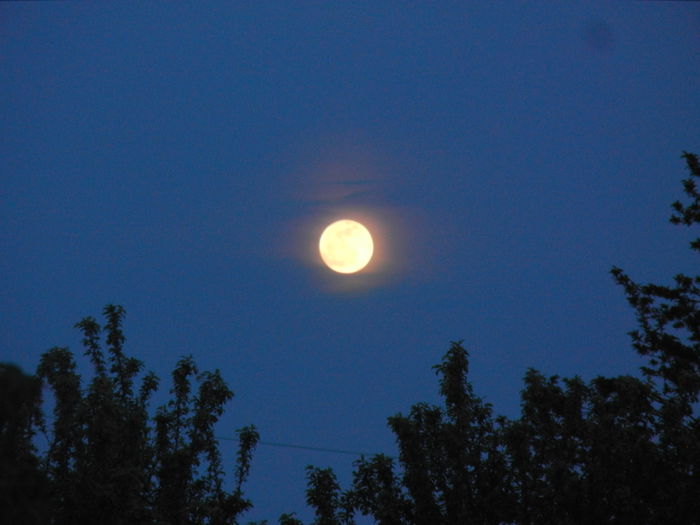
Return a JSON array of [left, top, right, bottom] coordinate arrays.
[[612, 152, 700, 523]]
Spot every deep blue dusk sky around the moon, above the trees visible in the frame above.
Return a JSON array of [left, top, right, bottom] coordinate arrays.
[[0, 1, 700, 520]]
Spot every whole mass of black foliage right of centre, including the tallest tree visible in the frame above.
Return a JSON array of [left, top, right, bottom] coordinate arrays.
[[307, 153, 700, 525]]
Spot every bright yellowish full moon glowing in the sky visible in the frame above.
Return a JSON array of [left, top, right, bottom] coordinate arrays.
[[318, 219, 374, 273]]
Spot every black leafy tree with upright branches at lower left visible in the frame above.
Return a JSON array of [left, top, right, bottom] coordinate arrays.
[[32, 305, 258, 525]]
